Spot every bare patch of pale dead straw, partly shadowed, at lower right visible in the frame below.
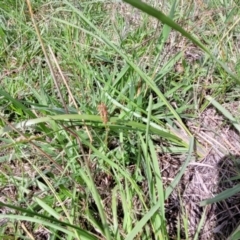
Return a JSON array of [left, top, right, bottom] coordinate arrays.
[[166, 108, 240, 240]]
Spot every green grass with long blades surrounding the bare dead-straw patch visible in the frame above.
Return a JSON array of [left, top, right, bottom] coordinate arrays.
[[0, 0, 240, 240]]
